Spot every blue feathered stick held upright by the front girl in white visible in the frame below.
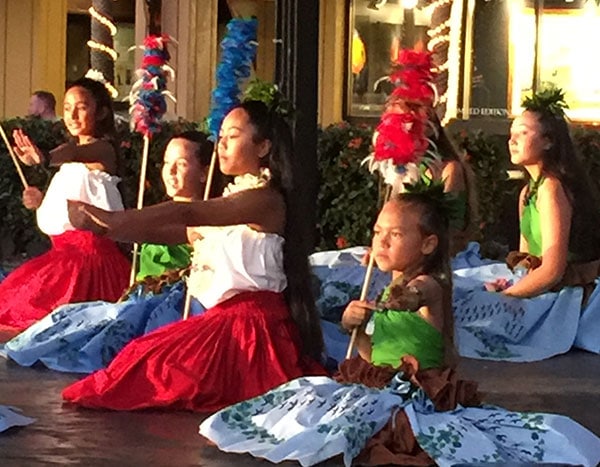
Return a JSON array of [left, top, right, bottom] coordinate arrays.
[[183, 18, 258, 319]]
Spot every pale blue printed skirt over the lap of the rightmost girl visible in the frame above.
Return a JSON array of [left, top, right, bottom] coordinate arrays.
[[452, 263, 583, 362]]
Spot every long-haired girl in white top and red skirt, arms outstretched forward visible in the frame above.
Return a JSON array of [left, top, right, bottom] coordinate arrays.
[[63, 102, 323, 411]]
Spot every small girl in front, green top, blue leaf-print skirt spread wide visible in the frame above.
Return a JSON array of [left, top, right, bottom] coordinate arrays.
[[200, 193, 600, 466]]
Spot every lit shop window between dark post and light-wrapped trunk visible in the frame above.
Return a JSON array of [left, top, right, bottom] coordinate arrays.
[[346, 0, 431, 117]]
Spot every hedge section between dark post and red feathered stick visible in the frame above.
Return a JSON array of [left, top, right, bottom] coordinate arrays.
[[317, 122, 379, 250]]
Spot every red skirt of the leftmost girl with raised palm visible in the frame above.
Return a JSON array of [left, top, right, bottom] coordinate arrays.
[[0, 230, 131, 331]]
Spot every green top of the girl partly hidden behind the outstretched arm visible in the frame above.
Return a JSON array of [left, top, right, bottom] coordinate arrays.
[[136, 243, 192, 280]]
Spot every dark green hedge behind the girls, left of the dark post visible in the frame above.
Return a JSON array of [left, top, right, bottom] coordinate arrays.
[[0, 118, 197, 259]]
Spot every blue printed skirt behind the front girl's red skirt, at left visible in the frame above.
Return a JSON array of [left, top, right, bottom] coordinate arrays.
[[2, 281, 203, 373]]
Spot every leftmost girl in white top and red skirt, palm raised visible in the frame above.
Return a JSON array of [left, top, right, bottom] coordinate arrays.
[[0, 78, 130, 330]]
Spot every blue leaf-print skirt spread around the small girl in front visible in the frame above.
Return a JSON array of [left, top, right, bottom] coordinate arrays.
[[200, 373, 600, 466]]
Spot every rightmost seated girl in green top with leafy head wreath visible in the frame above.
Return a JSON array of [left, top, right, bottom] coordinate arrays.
[[454, 91, 600, 361]]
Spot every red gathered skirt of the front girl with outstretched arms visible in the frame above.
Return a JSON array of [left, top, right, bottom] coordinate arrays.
[[63, 292, 326, 412]]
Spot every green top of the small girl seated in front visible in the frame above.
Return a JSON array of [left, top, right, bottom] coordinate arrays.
[[371, 289, 444, 369]]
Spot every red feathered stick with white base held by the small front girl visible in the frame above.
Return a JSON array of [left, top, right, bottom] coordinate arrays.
[[346, 50, 436, 358]]
